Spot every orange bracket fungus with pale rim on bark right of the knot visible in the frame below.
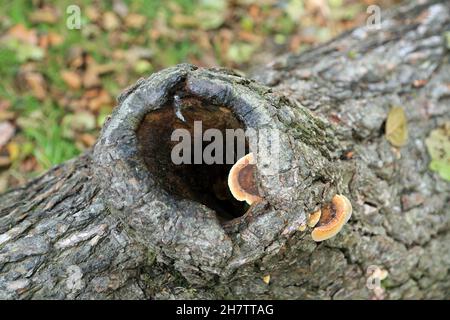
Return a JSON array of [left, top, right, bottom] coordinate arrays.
[[311, 195, 352, 241]]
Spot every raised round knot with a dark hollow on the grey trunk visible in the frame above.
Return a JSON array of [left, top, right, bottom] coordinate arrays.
[[94, 64, 348, 284]]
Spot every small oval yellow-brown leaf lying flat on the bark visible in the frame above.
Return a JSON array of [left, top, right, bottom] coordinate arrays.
[[385, 107, 408, 147]]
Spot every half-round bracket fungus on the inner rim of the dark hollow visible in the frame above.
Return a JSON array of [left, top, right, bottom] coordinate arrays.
[[228, 153, 261, 205]]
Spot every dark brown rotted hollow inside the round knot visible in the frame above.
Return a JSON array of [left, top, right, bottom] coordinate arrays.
[[137, 97, 249, 221]]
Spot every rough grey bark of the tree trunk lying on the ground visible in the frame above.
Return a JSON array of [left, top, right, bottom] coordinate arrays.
[[0, 1, 450, 299]]
